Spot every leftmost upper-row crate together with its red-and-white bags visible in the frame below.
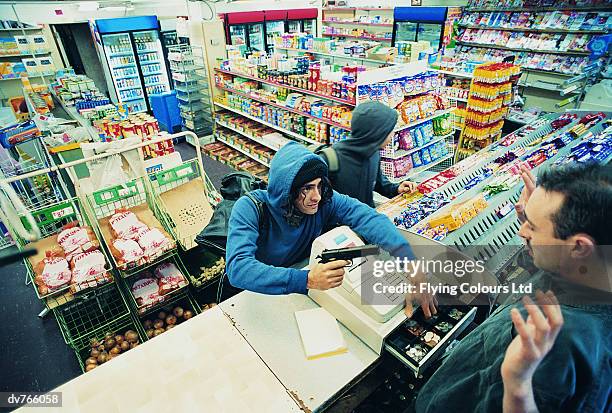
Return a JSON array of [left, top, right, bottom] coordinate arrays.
[[15, 198, 113, 309]]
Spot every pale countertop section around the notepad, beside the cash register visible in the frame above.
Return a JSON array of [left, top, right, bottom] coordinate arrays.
[[219, 291, 379, 411]]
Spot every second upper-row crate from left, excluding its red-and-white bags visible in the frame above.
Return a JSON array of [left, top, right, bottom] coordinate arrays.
[[87, 178, 176, 277]]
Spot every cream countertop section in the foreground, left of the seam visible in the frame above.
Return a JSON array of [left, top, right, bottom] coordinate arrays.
[[17, 307, 302, 413]]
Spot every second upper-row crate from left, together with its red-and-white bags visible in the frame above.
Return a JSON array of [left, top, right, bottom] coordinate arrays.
[[87, 178, 176, 277]]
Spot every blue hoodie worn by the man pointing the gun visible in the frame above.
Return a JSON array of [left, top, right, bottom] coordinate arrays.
[[226, 142, 414, 294]]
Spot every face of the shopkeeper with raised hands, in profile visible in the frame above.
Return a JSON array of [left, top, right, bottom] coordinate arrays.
[[519, 187, 571, 273]]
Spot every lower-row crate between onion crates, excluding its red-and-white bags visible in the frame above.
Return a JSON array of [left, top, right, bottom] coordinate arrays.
[[122, 254, 189, 316]]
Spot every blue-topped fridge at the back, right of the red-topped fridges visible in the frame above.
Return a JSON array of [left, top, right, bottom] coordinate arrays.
[[392, 7, 447, 50]]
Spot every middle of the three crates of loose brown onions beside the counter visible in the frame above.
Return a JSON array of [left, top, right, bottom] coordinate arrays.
[[138, 295, 200, 340]]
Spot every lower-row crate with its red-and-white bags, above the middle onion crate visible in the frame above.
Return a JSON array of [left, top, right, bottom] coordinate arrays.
[[123, 255, 189, 317]]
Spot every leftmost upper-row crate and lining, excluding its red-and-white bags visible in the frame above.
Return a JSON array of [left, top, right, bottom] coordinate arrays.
[[14, 198, 113, 309]]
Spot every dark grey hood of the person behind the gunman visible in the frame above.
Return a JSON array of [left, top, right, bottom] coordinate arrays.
[[337, 102, 397, 158]]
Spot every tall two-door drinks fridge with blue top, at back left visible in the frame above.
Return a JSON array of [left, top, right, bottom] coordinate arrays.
[[90, 16, 170, 113]]
